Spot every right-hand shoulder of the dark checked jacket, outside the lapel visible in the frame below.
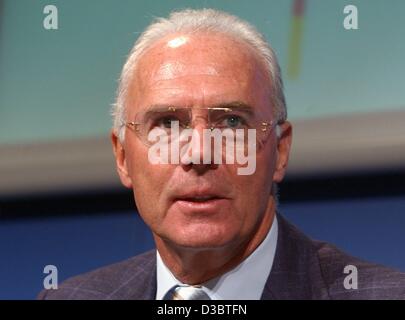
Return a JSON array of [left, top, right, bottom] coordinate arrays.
[[313, 240, 405, 299]]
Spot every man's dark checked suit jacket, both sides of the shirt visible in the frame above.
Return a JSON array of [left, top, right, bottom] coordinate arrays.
[[38, 215, 405, 300]]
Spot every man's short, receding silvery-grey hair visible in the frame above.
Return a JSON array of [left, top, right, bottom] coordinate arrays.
[[112, 9, 287, 142]]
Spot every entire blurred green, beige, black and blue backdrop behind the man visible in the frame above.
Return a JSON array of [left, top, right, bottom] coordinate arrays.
[[0, 0, 405, 299]]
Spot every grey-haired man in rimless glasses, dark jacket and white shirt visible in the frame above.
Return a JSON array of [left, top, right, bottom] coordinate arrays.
[[40, 9, 405, 300]]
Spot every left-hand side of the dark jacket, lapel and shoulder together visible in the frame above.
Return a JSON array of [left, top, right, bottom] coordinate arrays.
[[38, 250, 156, 300]]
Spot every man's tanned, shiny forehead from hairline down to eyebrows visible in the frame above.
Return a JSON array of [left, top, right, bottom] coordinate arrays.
[[128, 33, 269, 111]]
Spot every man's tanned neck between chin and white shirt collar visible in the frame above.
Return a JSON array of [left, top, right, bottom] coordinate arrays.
[[154, 197, 275, 285]]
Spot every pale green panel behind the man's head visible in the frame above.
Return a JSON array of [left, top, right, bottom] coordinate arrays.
[[0, 0, 405, 144]]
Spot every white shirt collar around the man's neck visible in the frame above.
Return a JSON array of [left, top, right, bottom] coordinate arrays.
[[156, 215, 278, 300]]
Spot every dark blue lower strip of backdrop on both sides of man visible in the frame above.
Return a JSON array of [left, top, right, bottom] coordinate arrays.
[[0, 196, 405, 299]]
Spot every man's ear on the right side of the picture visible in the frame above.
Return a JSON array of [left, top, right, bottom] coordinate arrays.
[[273, 121, 292, 183]]
